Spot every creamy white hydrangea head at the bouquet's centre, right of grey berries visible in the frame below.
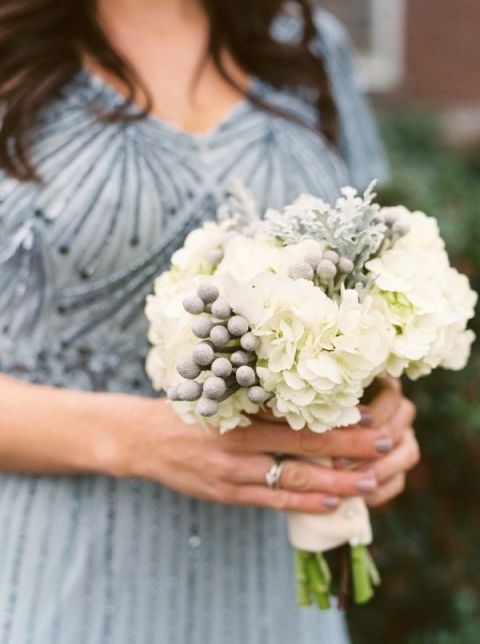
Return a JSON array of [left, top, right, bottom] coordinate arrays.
[[223, 272, 394, 431]]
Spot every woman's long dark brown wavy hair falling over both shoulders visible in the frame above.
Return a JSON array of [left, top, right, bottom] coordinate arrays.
[[0, 0, 336, 180]]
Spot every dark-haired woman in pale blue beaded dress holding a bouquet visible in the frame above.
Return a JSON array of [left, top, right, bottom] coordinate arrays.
[[0, 0, 418, 644]]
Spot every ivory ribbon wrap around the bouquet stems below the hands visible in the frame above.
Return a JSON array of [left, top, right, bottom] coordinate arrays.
[[288, 459, 372, 552]]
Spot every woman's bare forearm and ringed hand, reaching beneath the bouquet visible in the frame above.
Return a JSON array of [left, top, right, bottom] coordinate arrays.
[[0, 376, 413, 512]]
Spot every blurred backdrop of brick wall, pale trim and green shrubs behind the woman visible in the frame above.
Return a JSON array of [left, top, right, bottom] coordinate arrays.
[[320, 0, 480, 644]]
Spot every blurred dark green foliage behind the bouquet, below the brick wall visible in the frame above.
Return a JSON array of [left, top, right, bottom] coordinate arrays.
[[349, 113, 480, 644]]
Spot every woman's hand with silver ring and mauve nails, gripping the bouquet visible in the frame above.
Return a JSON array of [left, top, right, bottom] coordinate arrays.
[[110, 378, 418, 513]]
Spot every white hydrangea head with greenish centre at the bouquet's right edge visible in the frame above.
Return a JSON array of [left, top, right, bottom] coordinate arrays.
[[366, 208, 477, 379]]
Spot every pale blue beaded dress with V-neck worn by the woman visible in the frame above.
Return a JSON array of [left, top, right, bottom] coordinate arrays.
[[0, 14, 385, 644]]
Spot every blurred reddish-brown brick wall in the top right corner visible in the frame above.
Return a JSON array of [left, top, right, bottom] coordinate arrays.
[[404, 0, 480, 106]]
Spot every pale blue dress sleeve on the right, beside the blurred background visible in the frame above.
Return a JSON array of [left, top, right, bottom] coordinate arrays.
[[312, 10, 389, 190]]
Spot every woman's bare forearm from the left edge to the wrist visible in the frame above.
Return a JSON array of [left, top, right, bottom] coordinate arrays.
[[0, 374, 132, 474]]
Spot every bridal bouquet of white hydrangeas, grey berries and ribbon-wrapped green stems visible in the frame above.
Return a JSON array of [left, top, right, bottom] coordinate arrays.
[[146, 184, 476, 607]]
